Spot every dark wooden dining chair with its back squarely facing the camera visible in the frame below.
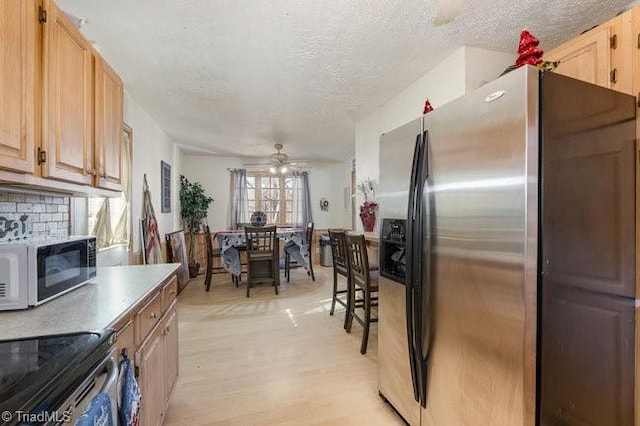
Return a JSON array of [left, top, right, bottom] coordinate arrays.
[[244, 226, 280, 297]]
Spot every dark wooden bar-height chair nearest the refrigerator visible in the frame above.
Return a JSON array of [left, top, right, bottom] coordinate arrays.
[[345, 231, 379, 354]]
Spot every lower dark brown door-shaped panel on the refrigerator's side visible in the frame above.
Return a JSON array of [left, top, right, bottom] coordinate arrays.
[[540, 280, 635, 425]]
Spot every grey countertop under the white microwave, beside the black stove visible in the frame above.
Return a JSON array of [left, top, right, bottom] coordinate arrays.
[[0, 263, 180, 340]]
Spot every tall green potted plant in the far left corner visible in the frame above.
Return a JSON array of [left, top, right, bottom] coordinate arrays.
[[180, 175, 213, 278]]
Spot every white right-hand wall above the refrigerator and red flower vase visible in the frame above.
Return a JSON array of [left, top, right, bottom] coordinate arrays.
[[355, 46, 515, 231]]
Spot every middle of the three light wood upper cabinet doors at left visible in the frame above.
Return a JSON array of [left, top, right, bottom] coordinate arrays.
[[42, 0, 96, 185]]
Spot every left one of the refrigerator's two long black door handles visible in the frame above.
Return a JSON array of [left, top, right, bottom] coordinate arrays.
[[405, 134, 423, 402]]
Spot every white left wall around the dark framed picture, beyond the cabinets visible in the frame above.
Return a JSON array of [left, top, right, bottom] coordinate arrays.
[[124, 92, 181, 252]]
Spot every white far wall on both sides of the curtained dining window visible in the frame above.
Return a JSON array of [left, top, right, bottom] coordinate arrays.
[[181, 154, 345, 230]]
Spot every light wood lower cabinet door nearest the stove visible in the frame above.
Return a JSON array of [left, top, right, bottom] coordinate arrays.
[[136, 325, 166, 426]]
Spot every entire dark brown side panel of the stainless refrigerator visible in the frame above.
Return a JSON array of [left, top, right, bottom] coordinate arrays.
[[538, 73, 636, 426]]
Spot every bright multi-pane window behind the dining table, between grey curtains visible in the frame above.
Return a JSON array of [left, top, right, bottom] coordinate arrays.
[[247, 172, 295, 225]]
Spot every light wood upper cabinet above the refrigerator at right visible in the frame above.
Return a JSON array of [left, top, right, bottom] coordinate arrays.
[[544, 12, 633, 93]]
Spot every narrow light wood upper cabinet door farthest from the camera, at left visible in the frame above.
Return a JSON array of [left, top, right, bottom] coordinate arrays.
[[94, 54, 123, 191]]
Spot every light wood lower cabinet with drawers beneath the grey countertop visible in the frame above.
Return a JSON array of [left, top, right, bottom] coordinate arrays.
[[112, 275, 178, 426]]
